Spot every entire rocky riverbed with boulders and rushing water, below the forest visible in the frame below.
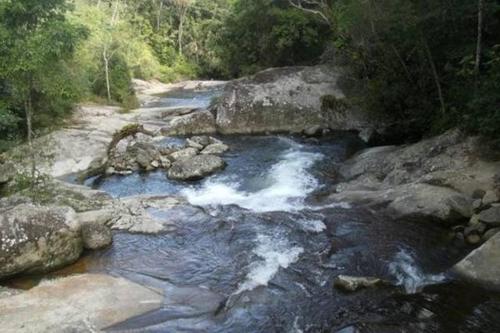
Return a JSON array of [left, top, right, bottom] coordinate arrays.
[[0, 66, 500, 332]]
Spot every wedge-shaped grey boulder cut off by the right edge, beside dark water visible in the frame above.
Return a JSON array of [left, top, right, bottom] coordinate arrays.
[[453, 233, 500, 289]]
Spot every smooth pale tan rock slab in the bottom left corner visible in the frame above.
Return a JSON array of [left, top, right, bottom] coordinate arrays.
[[0, 274, 163, 333]]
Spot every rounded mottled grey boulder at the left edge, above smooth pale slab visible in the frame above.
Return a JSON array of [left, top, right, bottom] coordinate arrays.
[[0, 204, 83, 279]]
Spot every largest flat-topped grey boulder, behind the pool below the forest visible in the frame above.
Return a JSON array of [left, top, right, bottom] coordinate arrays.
[[216, 65, 376, 139]]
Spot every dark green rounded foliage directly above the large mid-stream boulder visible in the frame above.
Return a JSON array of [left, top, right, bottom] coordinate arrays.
[[221, 0, 330, 77]]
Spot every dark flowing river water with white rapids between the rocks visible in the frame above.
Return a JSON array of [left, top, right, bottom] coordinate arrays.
[[14, 87, 500, 333]]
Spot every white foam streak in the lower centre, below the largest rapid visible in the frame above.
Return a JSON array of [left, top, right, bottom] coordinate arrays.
[[235, 235, 304, 295]]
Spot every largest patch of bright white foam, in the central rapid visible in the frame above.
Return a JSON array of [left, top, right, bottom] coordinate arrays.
[[182, 147, 323, 212]]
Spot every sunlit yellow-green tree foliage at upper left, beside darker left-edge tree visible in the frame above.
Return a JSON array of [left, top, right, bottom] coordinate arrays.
[[70, 1, 160, 104]]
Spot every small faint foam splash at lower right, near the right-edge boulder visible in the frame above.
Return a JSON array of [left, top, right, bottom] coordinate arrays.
[[389, 249, 446, 294]]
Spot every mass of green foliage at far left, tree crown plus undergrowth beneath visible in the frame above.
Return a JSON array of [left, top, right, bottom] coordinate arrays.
[[0, 0, 86, 150]]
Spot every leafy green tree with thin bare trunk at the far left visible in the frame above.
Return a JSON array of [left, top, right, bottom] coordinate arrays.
[[0, 0, 86, 179]]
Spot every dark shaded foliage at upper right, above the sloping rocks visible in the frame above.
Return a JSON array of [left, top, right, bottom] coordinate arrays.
[[331, 0, 500, 140]]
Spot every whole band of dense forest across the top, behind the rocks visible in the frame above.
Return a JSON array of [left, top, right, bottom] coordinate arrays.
[[0, 0, 500, 150]]
